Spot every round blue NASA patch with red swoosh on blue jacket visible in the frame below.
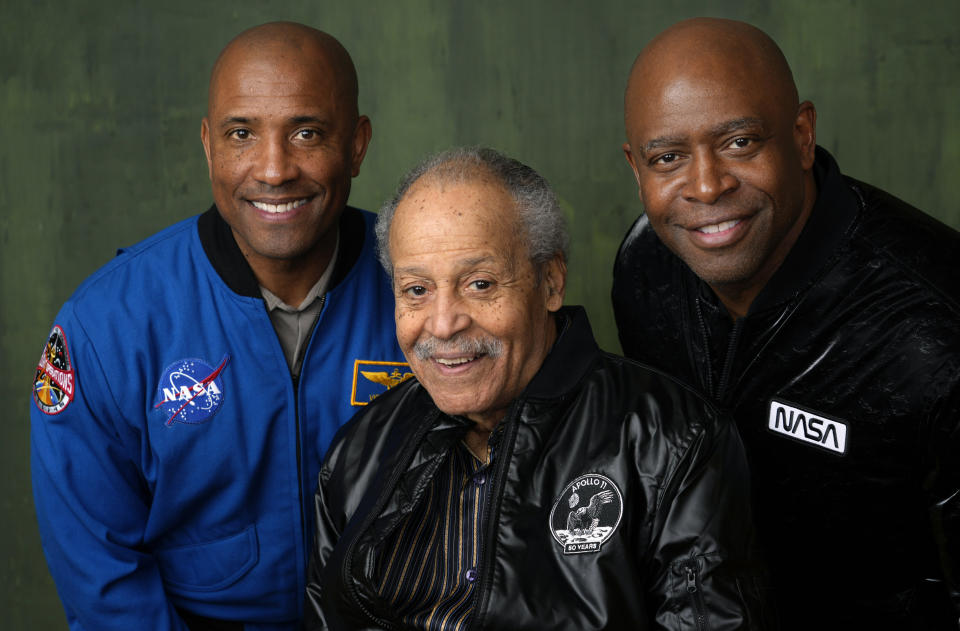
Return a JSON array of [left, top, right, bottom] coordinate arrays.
[[154, 355, 230, 427]]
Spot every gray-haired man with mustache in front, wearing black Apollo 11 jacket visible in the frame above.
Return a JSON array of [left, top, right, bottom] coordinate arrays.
[[307, 149, 759, 631]]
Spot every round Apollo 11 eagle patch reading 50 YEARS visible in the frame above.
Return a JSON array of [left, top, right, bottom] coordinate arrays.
[[550, 473, 623, 554]]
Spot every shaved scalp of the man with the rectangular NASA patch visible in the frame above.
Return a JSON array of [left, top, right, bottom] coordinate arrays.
[[624, 18, 799, 138]]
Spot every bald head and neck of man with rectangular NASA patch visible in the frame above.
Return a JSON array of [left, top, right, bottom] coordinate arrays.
[[623, 18, 816, 317]]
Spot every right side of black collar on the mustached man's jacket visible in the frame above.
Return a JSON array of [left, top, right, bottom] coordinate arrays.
[[522, 306, 600, 399]]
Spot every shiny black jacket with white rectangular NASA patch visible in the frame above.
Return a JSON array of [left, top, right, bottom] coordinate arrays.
[[613, 148, 960, 630]]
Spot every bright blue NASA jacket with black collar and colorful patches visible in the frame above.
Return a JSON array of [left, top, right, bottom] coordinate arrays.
[[31, 208, 408, 631]]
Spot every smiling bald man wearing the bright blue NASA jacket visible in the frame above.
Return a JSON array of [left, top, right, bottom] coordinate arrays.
[[32, 23, 406, 631]]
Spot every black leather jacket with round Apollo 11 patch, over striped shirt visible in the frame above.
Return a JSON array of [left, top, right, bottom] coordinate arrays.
[[306, 308, 763, 631]]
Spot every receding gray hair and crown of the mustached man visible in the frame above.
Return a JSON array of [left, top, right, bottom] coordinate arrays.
[[376, 147, 570, 277]]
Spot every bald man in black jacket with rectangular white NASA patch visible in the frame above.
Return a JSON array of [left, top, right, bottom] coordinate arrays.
[[613, 19, 960, 630]]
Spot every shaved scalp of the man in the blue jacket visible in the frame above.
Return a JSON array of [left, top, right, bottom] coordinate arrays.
[[207, 22, 358, 119]]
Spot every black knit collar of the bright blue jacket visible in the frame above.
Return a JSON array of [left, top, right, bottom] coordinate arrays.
[[197, 205, 366, 298]]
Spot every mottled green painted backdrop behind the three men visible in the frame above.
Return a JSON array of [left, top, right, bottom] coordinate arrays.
[[0, 0, 960, 630]]
